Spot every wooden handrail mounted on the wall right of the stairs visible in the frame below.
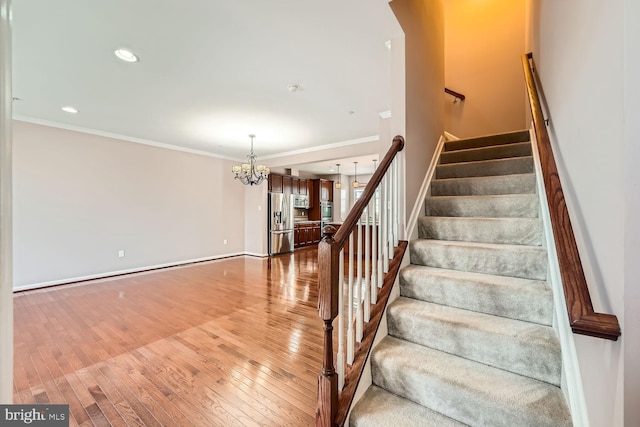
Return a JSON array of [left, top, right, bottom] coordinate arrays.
[[522, 53, 620, 341]]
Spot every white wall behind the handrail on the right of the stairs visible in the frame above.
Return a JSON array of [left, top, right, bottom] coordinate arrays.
[[529, 0, 640, 427]]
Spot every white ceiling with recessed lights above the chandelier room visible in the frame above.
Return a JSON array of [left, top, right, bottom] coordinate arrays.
[[13, 0, 402, 163]]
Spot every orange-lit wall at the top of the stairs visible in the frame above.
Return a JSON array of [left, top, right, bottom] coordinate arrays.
[[444, 0, 527, 138]]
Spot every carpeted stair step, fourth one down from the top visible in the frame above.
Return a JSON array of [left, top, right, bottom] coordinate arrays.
[[431, 173, 536, 196]]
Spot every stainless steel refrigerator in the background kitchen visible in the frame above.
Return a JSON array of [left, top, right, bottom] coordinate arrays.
[[269, 193, 293, 255]]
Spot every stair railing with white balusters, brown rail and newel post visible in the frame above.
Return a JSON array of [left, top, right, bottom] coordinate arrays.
[[316, 136, 407, 427]]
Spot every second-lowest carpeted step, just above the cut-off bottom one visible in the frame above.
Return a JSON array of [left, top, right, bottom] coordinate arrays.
[[372, 336, 571, 427]]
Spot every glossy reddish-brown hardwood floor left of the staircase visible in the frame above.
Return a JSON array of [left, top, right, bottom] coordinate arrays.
[[14, 248, 322, 426]]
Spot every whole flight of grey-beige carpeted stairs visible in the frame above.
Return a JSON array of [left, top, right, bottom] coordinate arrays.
[[350, 131, 571, 427]]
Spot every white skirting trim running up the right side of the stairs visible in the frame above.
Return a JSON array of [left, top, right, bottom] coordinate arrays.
[[529, 126, 590, 427]]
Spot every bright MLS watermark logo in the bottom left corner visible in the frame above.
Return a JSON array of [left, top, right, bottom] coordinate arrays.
[[0, 405, 69, 427]]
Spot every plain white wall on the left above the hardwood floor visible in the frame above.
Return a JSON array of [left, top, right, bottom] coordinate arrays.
[[13, 121, 245, 288]]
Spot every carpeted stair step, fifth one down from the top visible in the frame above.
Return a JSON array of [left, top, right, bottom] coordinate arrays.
[[425, 194, 538, 218]]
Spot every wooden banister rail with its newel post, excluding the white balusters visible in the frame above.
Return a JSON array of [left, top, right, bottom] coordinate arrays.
[[316, 136, 404, 426]]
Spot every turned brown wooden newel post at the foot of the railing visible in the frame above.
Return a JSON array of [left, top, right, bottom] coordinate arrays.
[[316, 225, 340, 427]]
